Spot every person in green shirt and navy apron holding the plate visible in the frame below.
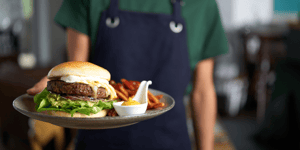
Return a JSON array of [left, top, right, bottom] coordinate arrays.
[[27, 0, 227, 150]]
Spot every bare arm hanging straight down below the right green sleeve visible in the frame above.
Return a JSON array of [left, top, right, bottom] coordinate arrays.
[[191, 59, 217, 150]]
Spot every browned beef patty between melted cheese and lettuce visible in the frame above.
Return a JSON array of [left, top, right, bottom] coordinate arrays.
[[47, 80, 109, 99]]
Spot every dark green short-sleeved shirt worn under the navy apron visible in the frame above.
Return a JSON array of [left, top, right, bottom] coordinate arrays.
[[55, 0, 228, 93]]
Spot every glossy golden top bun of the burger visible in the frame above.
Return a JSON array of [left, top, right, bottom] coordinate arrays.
[[48, 61, 110, 81]]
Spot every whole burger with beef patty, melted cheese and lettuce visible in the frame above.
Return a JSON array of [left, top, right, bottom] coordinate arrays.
[[34, 61, 117, 118]]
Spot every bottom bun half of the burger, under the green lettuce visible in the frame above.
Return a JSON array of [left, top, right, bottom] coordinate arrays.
[[47, 109, 108, 118]]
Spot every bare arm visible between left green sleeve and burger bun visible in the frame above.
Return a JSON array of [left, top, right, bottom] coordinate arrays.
[[67, 28, 90, 61]]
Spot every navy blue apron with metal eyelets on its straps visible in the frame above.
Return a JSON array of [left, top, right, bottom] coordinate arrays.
[[76, 0, 191, 150]]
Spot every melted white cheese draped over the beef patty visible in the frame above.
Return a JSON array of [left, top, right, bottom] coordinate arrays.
[[60, 75, 117, 99]]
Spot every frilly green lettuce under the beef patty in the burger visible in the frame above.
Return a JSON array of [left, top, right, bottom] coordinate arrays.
[[34, 88, 116, 117]]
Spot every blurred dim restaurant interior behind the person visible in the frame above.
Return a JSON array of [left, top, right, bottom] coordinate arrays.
[[0, 0, 300, 150]]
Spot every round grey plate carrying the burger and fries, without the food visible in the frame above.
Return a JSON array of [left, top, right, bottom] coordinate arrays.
[[13, 89, 175, 129]]
